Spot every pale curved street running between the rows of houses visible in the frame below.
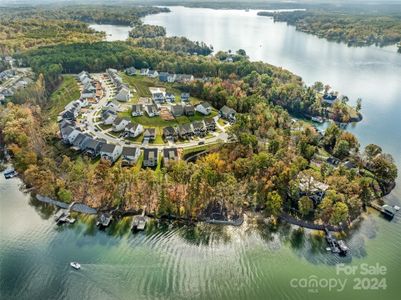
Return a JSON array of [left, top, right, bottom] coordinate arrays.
[[80, 74, 230, 150]]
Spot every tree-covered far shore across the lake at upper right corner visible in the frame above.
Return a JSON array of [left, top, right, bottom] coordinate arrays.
[[258, 10, 401, 51]]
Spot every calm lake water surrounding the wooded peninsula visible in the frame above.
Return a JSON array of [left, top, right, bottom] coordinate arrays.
[[0, 7, 401, 300]]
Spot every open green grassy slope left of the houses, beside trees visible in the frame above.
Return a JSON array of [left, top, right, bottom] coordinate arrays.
[[49, 76, 80, 120]]
